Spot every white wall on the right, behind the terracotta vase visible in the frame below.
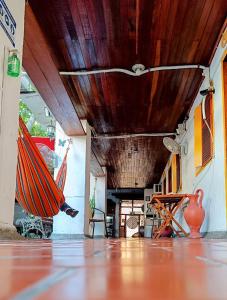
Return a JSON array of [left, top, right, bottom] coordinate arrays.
[[160, 40, 226, 232]]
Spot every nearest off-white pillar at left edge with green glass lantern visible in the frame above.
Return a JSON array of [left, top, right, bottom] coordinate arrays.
[[0, 0, 25, 235]]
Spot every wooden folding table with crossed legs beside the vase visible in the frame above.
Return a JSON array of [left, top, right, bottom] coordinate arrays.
[[150, 194, 189, 239]]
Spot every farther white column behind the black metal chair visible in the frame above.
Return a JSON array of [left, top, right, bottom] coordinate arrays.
[[90, 168, 107, 236]]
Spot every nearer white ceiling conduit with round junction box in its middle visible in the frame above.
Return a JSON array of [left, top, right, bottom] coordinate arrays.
[[59, 65, 207, 76]]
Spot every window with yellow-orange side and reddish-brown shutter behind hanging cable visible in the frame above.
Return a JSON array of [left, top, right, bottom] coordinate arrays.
[[194, 94, 213, 172]]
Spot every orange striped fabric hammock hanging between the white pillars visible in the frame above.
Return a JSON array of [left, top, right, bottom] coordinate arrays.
[[16, 118, 68, 217]]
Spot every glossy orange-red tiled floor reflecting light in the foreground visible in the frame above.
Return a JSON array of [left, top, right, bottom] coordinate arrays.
[[0, 239, 227, 300]]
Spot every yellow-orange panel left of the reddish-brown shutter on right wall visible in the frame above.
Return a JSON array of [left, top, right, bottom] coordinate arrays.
[[194, 104, 202, 168]]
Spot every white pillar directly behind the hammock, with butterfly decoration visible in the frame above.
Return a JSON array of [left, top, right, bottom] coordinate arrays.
[[53, 122, 91, 235]]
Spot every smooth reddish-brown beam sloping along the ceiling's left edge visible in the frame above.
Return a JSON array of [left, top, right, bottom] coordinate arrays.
[[23, 4, 85, 136]]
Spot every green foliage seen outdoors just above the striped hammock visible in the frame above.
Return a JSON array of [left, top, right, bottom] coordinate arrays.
[[19, 101, 48, 136]]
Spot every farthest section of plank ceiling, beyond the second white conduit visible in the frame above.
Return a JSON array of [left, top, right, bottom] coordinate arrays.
[[92, 137, 169, 188]]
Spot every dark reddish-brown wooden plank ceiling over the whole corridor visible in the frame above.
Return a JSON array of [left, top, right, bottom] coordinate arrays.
[[25, 0, 227, 188]]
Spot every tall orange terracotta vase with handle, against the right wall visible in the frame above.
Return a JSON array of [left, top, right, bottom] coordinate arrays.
[[184, 189, 205, 239]]
